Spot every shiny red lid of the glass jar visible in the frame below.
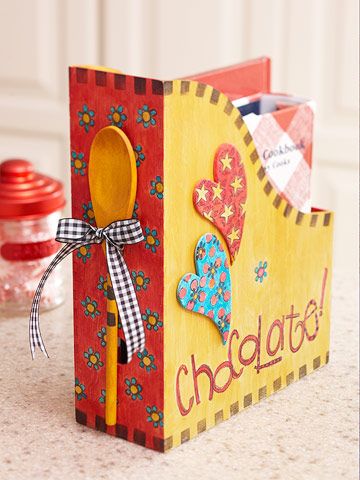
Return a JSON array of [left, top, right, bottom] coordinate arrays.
[[0, 159, 65, 220]]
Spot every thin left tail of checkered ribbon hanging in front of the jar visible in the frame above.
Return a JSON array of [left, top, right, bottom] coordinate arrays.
[[29, 242, 80, 359]]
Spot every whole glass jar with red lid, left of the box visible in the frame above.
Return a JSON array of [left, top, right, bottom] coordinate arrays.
[[0, 160, 65, 314]]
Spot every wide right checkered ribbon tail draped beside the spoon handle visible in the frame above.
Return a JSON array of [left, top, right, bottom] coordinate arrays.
[[106, 242, 145, 363]]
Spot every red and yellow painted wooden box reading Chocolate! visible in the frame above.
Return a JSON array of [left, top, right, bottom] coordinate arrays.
[[70, 62, 333, 452]]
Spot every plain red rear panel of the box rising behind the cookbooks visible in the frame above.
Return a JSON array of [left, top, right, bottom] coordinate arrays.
[[187, 57, 271, 100]]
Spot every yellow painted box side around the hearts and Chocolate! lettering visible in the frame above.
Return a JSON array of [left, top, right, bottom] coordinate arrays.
[[164, 81, 333, 449]]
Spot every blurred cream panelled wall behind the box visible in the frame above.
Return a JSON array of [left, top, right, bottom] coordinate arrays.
[[0, 0, 358, 267]]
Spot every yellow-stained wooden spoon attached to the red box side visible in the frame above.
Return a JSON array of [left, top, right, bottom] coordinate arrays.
[[89, 126, 137, 425]]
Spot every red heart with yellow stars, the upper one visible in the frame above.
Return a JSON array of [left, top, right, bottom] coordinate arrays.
[[193, 143, 247, 263]]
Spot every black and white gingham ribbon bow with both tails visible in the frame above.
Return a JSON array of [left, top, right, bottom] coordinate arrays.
[[29, 218, 145, 363]]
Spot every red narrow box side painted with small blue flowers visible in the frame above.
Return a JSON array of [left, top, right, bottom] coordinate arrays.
[[70, 67, 164, 450]]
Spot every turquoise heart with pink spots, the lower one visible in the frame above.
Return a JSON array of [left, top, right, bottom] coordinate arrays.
[[177, 233, 231, 345]]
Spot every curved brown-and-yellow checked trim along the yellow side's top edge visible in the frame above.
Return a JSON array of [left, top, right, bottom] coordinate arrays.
[[163, 80, 333, 228]]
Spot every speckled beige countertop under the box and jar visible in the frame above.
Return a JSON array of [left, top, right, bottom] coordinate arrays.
[[0, 266, 358, 480]]
